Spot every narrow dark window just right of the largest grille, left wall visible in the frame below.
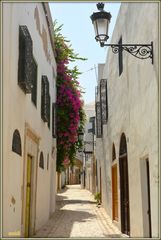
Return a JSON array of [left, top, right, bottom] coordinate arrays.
[[31, 58, 37, 106]]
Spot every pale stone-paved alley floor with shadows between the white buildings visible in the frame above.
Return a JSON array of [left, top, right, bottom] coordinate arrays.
[[34, 185, 127, 239]]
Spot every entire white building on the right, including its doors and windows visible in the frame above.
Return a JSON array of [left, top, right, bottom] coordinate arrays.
[[96, 2, 159, 237]]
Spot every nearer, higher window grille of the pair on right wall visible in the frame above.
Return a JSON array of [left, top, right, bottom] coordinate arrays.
[[100, 79, 108, 124]]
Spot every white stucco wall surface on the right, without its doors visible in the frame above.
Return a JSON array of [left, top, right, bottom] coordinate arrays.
[[97, 3, 159, 237]]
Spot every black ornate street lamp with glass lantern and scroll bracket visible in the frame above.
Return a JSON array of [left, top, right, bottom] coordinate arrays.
[[91, 3, 153, 64]]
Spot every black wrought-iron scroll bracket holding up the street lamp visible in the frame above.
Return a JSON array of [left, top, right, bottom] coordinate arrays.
[[100, 42, 153, 64]]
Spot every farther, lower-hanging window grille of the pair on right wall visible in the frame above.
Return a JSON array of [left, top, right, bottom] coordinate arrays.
[[96, 102, 102, 138]]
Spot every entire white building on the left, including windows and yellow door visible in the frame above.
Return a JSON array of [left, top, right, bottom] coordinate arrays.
[[2, 2, 56, 237]]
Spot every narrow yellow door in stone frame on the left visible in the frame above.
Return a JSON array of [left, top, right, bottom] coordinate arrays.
[[25, 155, 32, 237]]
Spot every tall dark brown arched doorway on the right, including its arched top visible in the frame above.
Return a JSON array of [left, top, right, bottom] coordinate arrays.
[[119, 133, 130, 235]]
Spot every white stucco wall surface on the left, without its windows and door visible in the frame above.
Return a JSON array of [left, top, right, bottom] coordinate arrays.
[[3, 3, 56, 237]]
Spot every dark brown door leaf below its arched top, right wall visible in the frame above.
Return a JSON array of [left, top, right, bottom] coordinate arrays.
[[119, 155, 130, 235]]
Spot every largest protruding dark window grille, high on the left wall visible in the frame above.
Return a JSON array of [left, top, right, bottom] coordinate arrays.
[[18, 26, 33, 93]]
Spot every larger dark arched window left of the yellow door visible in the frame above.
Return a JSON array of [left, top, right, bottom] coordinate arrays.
[[12, 129, 22, 156]]
